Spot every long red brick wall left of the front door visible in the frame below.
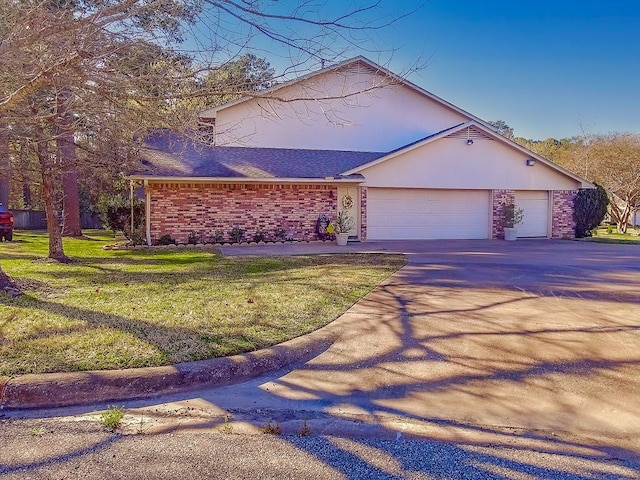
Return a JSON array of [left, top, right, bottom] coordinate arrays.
[[149, 183, 337, 243]]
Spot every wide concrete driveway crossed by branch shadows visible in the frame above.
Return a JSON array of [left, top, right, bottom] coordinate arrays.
[[225, 240, 640, 438]]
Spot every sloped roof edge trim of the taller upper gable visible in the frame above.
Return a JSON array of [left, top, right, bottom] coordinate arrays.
[[200, 55, 494, 129]]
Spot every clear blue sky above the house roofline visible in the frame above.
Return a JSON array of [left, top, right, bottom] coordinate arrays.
[[209, 0, 640, 139]]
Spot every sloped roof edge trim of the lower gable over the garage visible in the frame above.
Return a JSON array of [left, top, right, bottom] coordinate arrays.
[[343, 120, 593, 188]]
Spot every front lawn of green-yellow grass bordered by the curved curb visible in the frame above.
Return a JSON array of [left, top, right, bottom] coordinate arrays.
[[0, 231, 404, 376]]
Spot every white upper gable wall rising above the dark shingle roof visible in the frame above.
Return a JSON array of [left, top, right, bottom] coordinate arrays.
[[210, 63, 469, 151]]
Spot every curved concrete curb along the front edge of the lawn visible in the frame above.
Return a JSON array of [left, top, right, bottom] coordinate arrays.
[[0, 321, 338, 410]]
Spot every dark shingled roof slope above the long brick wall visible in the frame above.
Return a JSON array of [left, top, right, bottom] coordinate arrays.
[[131, 130, 385, 180]]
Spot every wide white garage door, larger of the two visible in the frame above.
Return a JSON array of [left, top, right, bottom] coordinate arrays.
[[367, 188, 491, 240]]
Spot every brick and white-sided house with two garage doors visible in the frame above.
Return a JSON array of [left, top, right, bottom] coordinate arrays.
[[131, 57, 591, 244]]
